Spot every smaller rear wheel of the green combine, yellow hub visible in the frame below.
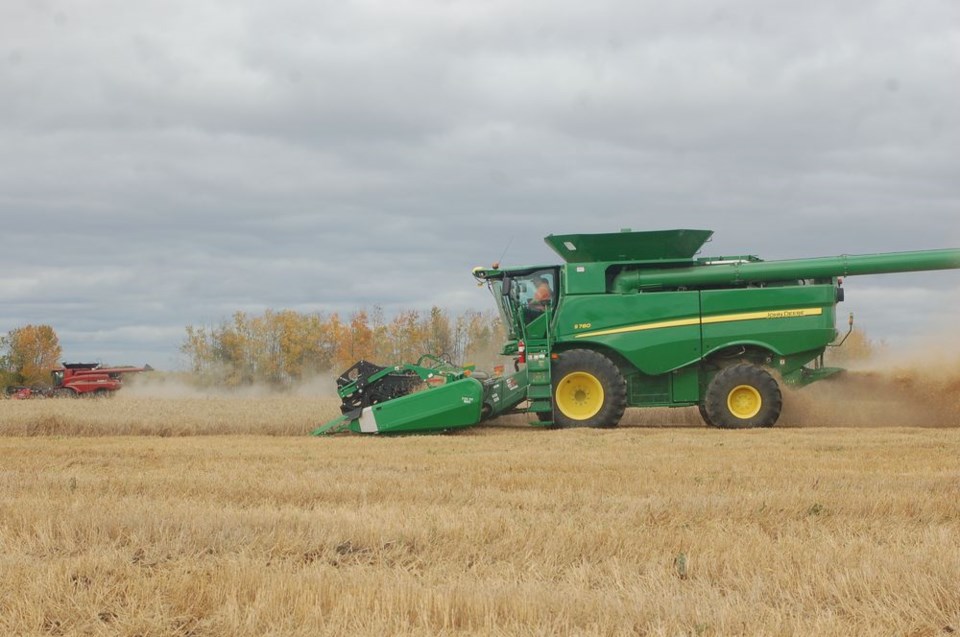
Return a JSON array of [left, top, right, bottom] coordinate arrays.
[[701, 363, 783, 429]]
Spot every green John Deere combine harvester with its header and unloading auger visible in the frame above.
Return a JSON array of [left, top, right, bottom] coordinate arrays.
[[313, 230, 960, 435]]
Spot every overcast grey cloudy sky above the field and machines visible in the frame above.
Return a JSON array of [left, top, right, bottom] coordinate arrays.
[[0, 0, 960, 369]]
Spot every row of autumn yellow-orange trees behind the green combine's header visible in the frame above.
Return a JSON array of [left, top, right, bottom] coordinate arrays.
[[180, 306, 503, 387]]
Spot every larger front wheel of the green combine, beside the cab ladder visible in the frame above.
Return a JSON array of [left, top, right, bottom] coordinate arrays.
[[552, 349, 627, 428]]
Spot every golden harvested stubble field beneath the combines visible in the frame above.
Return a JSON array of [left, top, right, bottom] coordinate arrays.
[[0, 372, 960, 636]]
